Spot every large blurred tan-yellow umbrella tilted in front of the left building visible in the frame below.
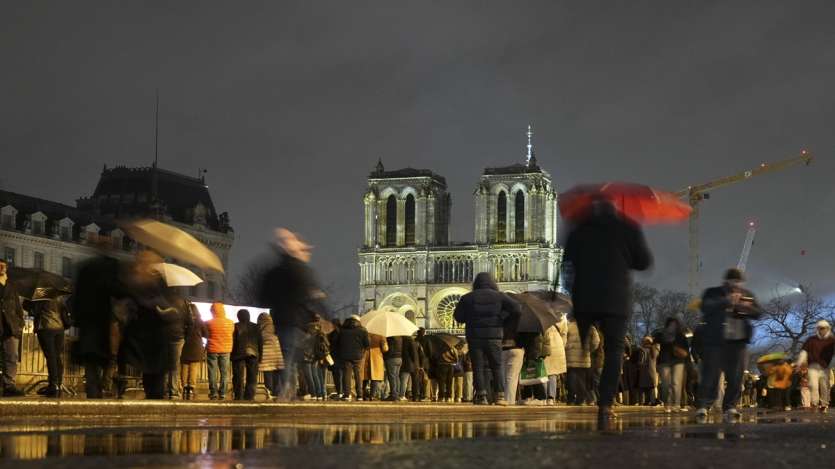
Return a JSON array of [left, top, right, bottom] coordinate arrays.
[[121, 220, 223, 272]]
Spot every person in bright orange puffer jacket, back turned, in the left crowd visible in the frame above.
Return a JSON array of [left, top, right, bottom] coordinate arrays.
[[206, 302, 235, 401]]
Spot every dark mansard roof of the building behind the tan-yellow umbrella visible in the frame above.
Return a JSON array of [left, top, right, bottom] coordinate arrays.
[[78, 166, 228, 231]]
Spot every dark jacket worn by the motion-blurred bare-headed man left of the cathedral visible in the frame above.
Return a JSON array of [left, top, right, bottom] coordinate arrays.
[[258, 254, 318, 330]]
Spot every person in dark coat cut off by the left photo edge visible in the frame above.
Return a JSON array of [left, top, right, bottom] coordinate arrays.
[[0, 259, 23, 396]]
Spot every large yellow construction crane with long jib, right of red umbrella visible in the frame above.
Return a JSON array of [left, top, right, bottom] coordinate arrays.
[[676, 150, 812, 296]]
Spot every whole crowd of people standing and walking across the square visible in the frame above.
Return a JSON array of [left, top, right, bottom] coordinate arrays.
[[0, 204, 835, 419]]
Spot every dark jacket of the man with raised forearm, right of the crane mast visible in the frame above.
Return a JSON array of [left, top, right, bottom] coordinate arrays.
[[699, 285, 762, 347]]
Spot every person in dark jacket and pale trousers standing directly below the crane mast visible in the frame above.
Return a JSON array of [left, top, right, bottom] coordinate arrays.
[[653, 317, 690, 413]]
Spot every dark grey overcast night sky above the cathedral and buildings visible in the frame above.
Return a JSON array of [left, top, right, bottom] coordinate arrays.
[[0, 0, 835, 302]]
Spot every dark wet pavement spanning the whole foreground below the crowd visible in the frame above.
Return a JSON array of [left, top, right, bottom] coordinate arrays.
[[0, 401, 835, 469]]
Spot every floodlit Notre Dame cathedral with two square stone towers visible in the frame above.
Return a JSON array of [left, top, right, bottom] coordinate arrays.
[[359, 127, 562, 330]]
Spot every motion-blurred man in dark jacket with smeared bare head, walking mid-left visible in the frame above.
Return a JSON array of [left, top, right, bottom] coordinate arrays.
[[258, 228, 324, 400]]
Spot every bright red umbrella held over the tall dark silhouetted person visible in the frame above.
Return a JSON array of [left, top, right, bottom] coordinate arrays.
[[560, 182, 693, 223]]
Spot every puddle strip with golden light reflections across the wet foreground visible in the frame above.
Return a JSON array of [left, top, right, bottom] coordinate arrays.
[[0, 411, 820, 460]]
